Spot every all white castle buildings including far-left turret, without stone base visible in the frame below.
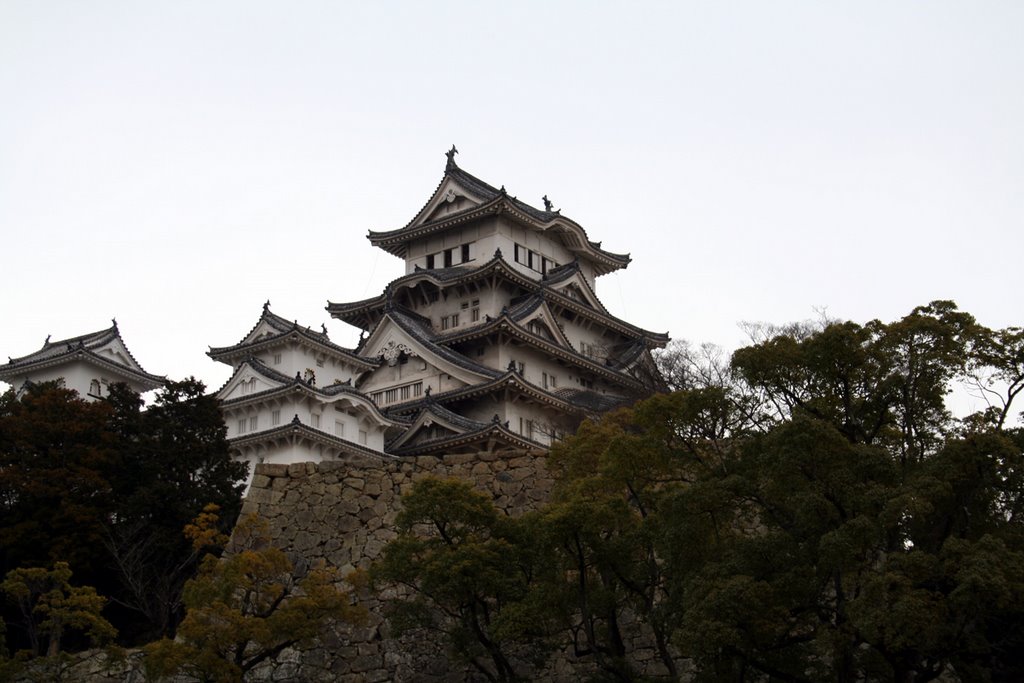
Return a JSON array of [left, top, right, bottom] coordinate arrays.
[[0, 146, 668, 481]]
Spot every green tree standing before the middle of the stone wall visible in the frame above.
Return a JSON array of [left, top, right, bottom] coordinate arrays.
[[373, 478, 560, 681]]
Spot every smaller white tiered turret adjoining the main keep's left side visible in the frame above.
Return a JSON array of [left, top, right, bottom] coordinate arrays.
[[208, 302, 407, 481]]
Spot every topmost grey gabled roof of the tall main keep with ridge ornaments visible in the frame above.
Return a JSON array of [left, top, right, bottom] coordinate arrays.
[[368, 153, 630, 275]]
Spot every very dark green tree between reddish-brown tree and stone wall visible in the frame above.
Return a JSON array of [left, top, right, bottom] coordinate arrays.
[[103, 379, 247, 642]]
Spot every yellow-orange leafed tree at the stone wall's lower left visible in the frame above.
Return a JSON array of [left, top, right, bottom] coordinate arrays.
[[145, 510, 364, 682]]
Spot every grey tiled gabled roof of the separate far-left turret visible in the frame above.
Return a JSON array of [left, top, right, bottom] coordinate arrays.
[[0, 321, 167, 389]]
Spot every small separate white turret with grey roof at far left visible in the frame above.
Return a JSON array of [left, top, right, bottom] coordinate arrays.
[[0, 321, 166, 400]]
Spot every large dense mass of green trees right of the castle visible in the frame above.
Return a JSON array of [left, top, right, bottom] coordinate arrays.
[[385, 301, 1024, 682]]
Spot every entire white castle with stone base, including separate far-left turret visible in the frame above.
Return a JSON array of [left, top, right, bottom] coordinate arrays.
[[0, 147, 668, 682]]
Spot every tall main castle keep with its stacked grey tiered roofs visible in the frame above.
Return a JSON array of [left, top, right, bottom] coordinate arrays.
[[327, 152, 668, 454]]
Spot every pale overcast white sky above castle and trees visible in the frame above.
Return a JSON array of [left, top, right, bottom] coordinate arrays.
[[0, 0, 1024, 395]]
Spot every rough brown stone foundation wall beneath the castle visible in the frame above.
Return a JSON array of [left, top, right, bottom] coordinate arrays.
[[234, 453, 667, 683]]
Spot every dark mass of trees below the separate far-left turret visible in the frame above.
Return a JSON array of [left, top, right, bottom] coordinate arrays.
[[0, 380, 245, 649]]
